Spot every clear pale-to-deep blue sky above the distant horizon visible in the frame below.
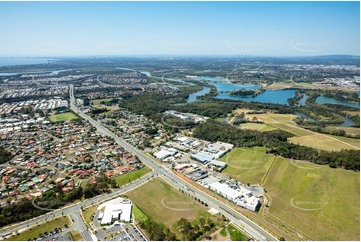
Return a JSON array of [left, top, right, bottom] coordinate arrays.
[[0, 2, 360, 57]]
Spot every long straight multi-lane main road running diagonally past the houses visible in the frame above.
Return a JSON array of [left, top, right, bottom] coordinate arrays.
[[69, 84, 277, 241]]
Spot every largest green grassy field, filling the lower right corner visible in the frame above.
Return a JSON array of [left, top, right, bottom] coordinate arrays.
[[263, 157, 360, 241]]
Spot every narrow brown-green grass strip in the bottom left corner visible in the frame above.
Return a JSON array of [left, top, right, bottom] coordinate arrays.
[[7, 216, 70, 241]]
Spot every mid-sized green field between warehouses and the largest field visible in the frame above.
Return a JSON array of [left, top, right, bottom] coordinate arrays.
[[220, 147, 275, 184]]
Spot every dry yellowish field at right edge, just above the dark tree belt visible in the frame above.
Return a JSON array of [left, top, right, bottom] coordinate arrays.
[[289, 134, 360, 150]]
